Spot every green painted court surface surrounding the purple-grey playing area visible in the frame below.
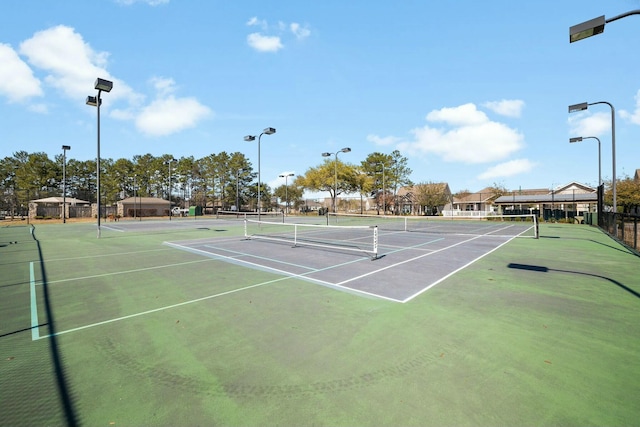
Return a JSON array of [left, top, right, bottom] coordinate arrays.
[[0, 219, 640, 426]]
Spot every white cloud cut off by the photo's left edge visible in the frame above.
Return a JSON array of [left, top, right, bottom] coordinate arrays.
[[0, 43, 43, 102]]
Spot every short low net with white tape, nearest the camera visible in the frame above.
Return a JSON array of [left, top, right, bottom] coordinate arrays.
[[244, 219, 378, 259]]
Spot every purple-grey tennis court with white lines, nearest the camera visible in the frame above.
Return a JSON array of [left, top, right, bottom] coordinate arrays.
[[167, 215, 536, 302]]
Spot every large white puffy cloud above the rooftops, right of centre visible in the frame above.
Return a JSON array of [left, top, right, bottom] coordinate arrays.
[[398, 104, 524, 164]]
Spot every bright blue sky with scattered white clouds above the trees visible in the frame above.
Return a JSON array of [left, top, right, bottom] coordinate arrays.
[[0, 0, 640, 197]]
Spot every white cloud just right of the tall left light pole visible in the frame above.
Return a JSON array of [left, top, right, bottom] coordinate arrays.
[[136, 95, 212, 136]]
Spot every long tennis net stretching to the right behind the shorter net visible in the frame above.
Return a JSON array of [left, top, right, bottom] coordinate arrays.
[[327, 212, 538, 239]]
